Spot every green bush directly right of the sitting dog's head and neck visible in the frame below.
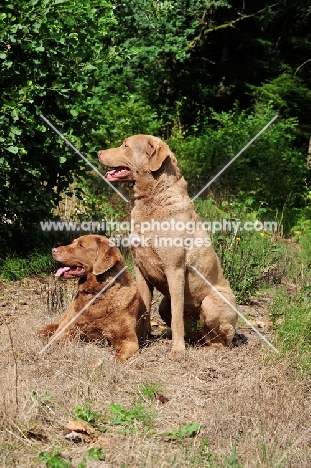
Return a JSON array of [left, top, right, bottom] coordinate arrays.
[[169, 106, 310, 209]]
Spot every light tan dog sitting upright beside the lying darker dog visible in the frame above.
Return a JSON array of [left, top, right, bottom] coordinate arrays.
[[98, 135, 237, 354]]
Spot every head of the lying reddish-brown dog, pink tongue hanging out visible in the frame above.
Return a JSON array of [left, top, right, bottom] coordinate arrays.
[[52, 234, 122, 278]]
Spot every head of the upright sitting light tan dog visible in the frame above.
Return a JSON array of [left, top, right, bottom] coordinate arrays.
[[98, 135, 177, 182]]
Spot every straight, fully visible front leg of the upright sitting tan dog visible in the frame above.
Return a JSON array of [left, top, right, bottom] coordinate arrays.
[[166, 267, 185, 355]]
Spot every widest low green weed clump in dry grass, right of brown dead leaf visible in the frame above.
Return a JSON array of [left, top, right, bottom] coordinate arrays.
[[109, 403, 155, 433]]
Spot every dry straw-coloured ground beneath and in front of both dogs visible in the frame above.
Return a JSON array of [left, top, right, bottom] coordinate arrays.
[[0, 276, 311, 468]]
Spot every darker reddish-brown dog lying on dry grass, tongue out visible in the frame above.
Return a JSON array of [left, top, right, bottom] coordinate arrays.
[[39, 235, 150, 362]]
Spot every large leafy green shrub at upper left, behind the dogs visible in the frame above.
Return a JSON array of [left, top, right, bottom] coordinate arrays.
[[0, 0, 157, 249]]
